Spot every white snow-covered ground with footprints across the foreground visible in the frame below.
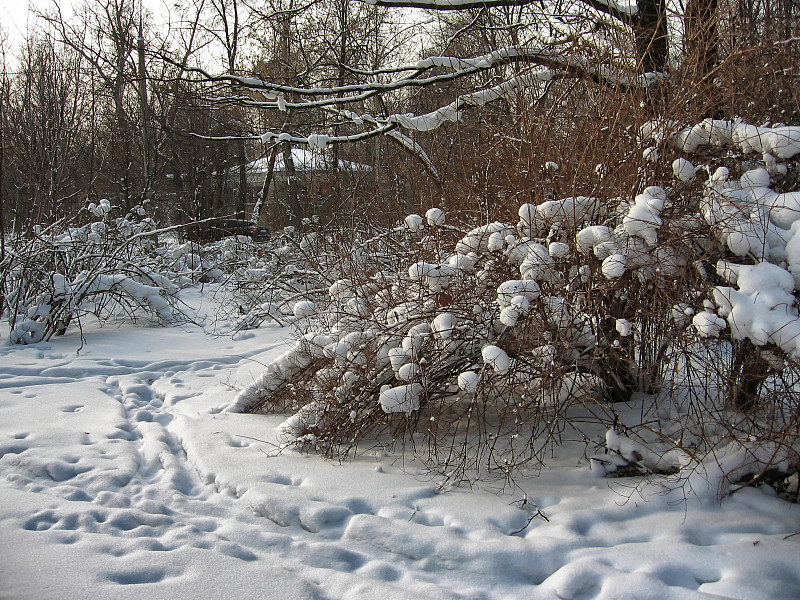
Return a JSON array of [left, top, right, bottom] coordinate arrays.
[[0, 290, 800, 600]]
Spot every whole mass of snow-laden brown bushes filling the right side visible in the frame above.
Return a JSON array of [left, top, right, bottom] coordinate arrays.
[[229, 121, 800, 490]]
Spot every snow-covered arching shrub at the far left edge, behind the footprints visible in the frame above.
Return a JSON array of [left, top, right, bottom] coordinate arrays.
[[0, 200, 179, 344]]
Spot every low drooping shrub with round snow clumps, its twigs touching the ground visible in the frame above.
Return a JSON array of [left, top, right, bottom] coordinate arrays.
[[225, 198, 676, 476]]
